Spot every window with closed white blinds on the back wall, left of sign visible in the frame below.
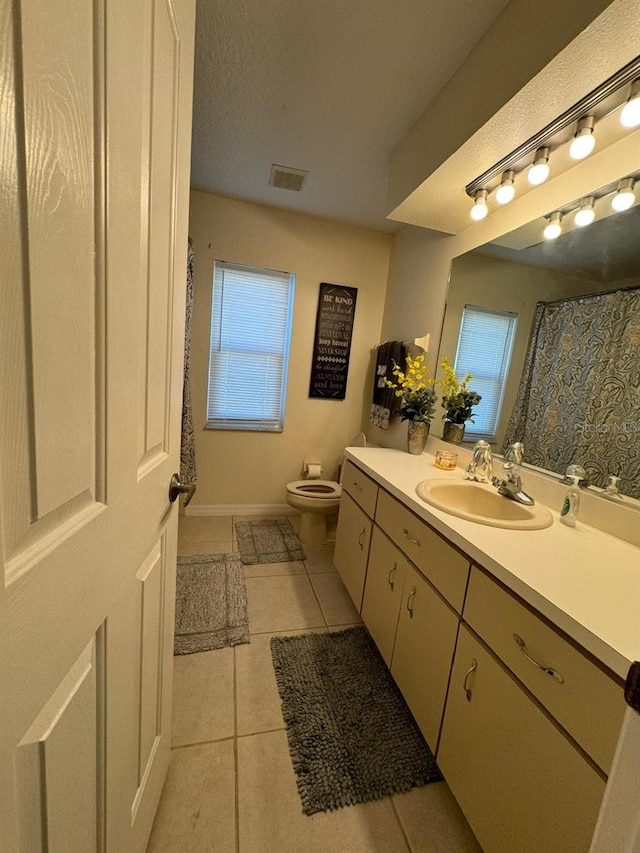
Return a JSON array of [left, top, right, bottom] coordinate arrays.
[[207, 261, 295, 432]]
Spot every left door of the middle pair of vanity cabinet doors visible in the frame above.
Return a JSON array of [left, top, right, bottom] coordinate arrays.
[[362, 526, 409, 667]]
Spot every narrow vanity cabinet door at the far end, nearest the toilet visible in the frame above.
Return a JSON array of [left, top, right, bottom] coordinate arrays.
[[333, 492, 373, 613]]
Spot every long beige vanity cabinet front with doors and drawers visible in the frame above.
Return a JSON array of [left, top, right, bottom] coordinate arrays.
[[335, 456, 625, 853]]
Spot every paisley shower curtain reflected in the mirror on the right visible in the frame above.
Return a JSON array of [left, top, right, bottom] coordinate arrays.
[[505, 288, 640, 498]]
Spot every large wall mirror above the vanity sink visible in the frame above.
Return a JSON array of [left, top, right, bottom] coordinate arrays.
[[440, 180, 640, 499]]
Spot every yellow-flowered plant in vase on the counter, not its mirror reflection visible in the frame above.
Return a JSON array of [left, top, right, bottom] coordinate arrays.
[[387, 355, 437, 455]]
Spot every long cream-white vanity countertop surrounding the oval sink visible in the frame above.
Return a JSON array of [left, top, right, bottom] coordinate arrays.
[[346, 447, 640, 679]]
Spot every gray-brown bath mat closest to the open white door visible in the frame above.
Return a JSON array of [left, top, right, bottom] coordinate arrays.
[[173, 554, 249, 655]]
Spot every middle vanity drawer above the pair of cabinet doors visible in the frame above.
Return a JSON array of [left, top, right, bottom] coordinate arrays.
[[376, 490, 469, 613]]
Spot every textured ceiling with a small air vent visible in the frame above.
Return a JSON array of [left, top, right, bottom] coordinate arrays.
[[191, 0, 507, 231]]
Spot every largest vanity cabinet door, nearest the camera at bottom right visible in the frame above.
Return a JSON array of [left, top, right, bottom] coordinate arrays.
[[438, 626, 605, 853]]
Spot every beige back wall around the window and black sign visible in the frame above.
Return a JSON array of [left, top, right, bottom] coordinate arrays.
[[189, 191, 392, 511]]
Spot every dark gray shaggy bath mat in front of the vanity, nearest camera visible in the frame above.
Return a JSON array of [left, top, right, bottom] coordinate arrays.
[[271, 626, 442, 815]]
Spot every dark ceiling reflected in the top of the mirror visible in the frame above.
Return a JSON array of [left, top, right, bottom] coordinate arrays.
[[475, 206, 640, 284]]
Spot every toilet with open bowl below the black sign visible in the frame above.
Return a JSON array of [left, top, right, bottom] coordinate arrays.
[[287, 432, 367, 545]]
